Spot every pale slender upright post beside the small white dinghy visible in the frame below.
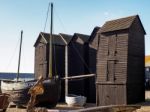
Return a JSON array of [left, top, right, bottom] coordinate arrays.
[[65, 44, 68, 96]]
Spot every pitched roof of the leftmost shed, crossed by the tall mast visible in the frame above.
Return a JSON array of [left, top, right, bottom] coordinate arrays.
[[34, 32, 65, 46]]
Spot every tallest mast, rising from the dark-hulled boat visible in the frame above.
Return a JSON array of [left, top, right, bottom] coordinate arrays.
[[49, 3, 53, 78]]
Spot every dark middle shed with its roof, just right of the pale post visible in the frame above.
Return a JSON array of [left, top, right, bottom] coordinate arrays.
[[65, 33, 89, 96]]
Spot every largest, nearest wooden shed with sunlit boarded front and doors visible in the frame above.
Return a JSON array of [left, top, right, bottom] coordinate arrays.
[[96, 15, 146, 106]]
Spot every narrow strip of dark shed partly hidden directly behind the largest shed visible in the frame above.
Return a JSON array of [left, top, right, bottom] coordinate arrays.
[[85, 27, 100, 103]]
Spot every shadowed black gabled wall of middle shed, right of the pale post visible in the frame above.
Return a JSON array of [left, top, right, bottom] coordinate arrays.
[[68, 36, 85, 95]]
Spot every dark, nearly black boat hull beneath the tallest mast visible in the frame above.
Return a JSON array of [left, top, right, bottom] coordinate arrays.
[[36, 79, 61, 108]]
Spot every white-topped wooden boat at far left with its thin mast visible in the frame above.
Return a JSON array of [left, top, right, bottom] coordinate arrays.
[[1, 31, 36, 106]]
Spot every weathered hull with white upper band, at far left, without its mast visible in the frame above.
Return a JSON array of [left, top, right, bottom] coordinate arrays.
[[1, 80, 36, 106]]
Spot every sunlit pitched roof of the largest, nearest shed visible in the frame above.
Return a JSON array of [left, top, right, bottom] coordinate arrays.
[[99, 15, 145, 33]]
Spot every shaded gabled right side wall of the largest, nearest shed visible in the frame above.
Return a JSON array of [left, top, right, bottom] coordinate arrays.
[[127, 18, 145, 103]]
